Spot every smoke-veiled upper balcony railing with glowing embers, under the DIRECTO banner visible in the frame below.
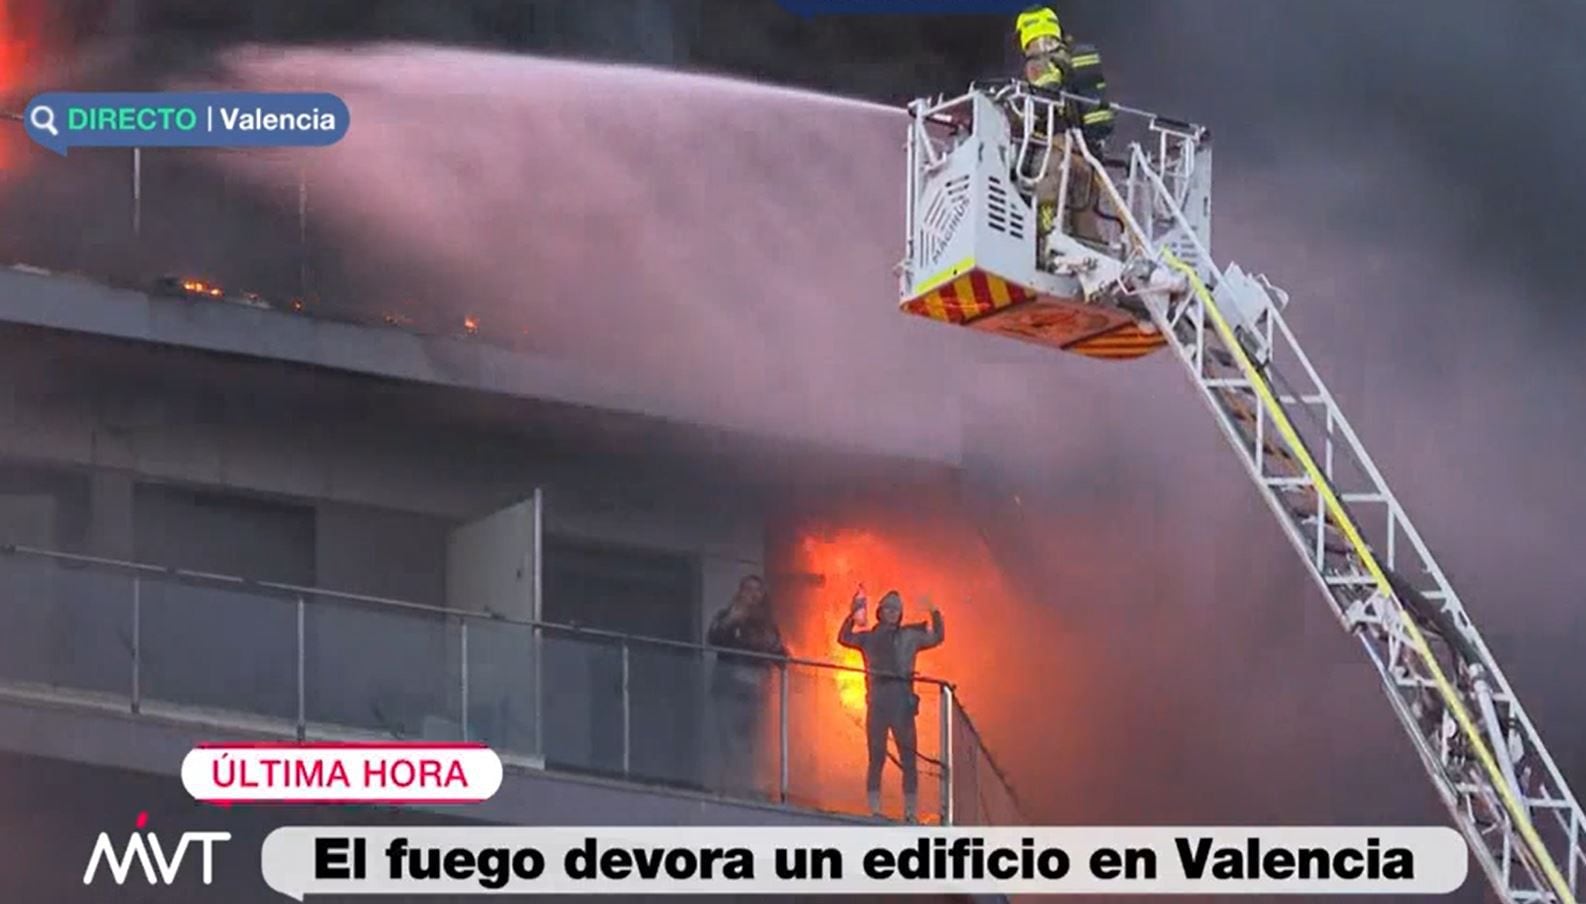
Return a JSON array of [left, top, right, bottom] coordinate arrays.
[[0, 138, 542, 349]]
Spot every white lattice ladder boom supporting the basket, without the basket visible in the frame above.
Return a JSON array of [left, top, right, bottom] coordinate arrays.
[[1097, 133, 1586, 904]]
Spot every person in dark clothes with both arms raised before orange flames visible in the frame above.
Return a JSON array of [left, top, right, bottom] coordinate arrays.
[[837, 590, 945, 823]]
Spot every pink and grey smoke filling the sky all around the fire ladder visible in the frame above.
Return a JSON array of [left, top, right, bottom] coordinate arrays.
[[3, 0, 1586, 899]]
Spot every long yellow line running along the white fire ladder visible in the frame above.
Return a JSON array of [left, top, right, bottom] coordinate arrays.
[[1163, 247, 1576, 904]]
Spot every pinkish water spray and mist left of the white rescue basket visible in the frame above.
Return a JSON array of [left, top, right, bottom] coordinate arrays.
[[170, 48, 964, 457]]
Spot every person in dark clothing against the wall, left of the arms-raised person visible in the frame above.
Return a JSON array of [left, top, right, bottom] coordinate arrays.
[[706, 574, 788, 793]]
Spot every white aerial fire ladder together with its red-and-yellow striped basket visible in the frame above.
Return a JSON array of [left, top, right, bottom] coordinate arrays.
[[899, 81, 1586, 904]]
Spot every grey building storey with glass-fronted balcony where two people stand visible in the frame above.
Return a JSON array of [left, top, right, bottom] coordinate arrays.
[[0, 260, 1015, 888]]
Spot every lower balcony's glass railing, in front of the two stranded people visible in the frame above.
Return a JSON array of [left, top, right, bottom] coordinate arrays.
[[0, 547, 1025, 825]]
